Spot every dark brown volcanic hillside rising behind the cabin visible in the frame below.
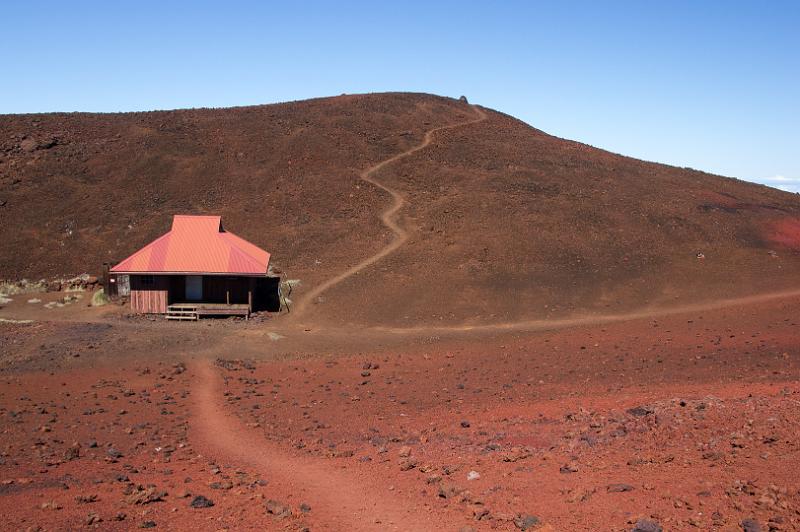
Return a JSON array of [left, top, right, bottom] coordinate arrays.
[[0, 94, 800, 327]]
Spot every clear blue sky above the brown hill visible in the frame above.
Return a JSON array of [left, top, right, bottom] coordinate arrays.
[[0, 0, 800, 191]]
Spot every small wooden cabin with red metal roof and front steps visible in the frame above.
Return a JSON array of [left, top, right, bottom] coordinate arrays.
[[109, 215, 280, 320]]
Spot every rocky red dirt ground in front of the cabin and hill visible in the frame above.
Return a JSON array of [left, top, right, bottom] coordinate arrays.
[[0, 295, 800, 531]]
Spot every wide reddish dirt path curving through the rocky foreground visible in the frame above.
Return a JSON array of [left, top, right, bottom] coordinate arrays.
[[190, 361, 440, 531]]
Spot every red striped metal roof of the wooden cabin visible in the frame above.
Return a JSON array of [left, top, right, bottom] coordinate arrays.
[[111, 215, 269, 275]]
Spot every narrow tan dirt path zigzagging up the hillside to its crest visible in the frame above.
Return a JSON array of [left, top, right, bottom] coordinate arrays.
[[292, 106, 486, 319]]
